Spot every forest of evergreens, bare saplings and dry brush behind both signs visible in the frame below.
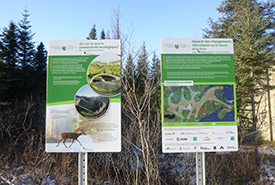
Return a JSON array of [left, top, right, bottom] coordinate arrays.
[[0, 0, 275, 184]]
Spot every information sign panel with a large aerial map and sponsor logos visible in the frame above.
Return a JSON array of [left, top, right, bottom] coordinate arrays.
[[160, 39, 238, 153]]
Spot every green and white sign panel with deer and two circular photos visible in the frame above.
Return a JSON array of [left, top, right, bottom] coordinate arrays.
[[46, 40, 121, 152]]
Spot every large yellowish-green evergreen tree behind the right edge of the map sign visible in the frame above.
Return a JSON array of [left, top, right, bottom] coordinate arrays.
[[204, 0, 275, 157]]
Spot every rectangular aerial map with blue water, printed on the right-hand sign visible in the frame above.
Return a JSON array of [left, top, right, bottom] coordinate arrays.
[[164, 85, 235, 122]]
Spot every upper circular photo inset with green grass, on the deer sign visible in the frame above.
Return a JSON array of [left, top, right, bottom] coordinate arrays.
[[87, 53, 121, 97]]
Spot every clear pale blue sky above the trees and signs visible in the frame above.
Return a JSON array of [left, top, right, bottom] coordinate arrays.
[[0, 0, 222, 54]]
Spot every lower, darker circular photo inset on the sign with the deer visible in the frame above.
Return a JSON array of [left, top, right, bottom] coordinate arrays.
[[74, 84, 110, 119]]
